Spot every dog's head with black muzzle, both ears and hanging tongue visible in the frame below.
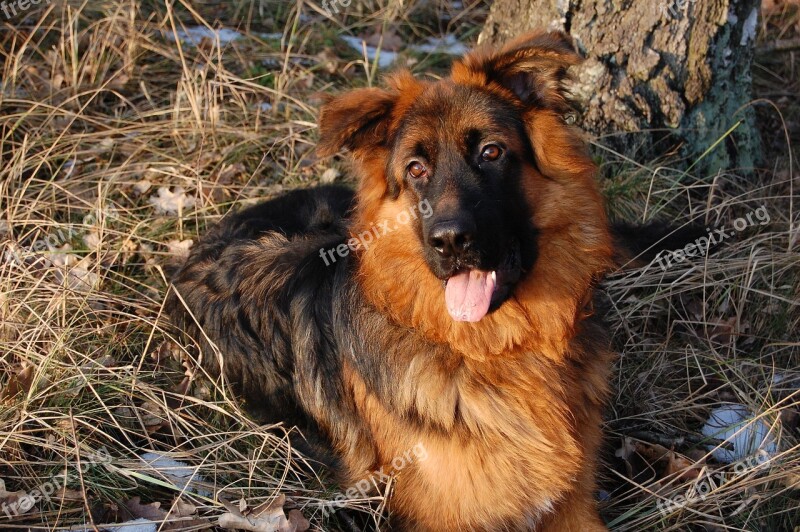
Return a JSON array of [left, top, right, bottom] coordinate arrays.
[[319, 33, 608, 332]]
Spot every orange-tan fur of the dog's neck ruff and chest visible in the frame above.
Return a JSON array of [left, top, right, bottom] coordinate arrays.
[[316, 31, 612, 531]]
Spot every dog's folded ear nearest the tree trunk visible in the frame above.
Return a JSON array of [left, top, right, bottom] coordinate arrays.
[[452, 31, 582, 111]]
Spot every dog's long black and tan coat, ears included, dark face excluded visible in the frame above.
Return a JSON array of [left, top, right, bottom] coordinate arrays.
[[168, 34, 612, 531]]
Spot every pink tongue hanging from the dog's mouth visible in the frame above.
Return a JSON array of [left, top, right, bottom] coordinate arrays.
[[444, 270, 496, 321]]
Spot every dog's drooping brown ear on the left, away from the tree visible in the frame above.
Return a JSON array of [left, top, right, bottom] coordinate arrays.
[[317, 88, 397, 157]]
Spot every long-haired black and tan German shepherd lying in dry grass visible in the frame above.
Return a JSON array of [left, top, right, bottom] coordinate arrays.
[[168, 33, 613, 532]]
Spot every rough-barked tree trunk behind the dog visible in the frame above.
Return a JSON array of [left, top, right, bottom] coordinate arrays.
[[479, 0, 760, 174]]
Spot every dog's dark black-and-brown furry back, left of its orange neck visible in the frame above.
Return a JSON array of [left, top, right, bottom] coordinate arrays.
[[166, 186, 353, 465]]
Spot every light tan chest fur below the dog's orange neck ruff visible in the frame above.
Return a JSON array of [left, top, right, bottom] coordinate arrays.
[[332, 294, 583, 530]]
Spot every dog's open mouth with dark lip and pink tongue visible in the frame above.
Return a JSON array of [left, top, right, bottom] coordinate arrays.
[[444, 242, 521, 322]]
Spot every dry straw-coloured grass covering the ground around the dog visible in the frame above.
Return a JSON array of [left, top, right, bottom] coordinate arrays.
[[0, 0, 800, 530]]
